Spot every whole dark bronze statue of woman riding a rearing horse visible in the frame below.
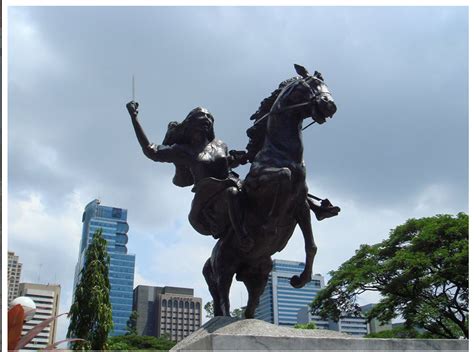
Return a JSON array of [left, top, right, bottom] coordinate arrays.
[[127, 65, 340, 318]]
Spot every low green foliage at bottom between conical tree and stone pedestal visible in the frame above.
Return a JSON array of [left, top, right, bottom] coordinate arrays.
[[108, 335, 176, 351]]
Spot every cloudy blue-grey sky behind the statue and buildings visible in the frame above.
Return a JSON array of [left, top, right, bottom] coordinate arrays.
[[8, 7, 468, 337]]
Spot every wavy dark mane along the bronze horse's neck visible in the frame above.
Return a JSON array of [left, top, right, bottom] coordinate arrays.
[[246, 77, 298, 162]]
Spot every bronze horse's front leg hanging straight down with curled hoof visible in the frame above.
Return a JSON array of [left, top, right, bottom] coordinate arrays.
[[290, 201, 318, 288]]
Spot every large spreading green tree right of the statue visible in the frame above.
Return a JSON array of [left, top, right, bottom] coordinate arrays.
[[311, 213, 469, 338]]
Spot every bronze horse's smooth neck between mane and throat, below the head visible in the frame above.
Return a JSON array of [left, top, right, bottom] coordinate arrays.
[[262, 112, 303, 163]]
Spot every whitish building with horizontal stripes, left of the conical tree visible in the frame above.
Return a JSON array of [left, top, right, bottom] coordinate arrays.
[[19, 283, 61, 351]]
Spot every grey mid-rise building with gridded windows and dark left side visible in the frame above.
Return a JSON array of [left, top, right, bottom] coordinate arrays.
[[133, 285, 202, 341]]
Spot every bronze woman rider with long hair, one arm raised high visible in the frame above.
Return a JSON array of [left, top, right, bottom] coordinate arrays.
[[127, 101, 254, 251]]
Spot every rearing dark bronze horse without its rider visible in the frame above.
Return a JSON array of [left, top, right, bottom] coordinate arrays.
[[203, 65, 339, 318]]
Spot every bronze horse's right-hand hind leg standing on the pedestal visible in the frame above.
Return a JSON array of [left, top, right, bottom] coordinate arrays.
[[239, 257, 273, 319]]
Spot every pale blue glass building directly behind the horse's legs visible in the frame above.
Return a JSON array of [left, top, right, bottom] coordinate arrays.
[[255, 259, 324, 326]]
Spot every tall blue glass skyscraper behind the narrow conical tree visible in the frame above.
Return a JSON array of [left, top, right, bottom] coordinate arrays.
[[74, 199, 135, 336]]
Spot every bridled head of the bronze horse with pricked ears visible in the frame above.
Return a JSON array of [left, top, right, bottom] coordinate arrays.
[[280, 65, 337, 124]]
